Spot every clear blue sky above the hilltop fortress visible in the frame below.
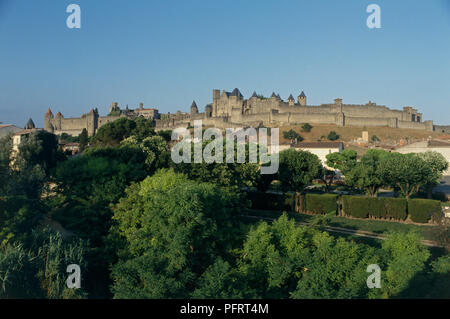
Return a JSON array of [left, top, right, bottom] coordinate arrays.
[[0, 0, 450, 127]]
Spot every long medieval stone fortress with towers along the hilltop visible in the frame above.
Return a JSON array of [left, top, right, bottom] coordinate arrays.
[[44, 88, 434, 135]]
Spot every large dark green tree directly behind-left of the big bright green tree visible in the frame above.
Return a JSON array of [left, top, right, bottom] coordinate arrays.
[[52, 146, 147, 246]]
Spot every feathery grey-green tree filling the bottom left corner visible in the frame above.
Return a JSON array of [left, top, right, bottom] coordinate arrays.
[[0, 229, 87, 299]]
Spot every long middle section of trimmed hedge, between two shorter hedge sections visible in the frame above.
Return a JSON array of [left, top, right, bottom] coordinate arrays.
[[342, 196, 407, 220]]
